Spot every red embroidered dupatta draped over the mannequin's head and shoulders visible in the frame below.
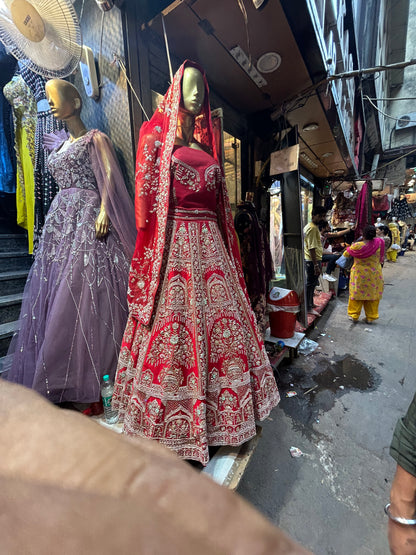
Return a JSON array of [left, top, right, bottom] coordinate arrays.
[[127, 60, 246, 325]]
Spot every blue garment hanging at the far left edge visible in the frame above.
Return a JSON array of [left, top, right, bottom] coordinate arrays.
[[0, 42, 17, 193]]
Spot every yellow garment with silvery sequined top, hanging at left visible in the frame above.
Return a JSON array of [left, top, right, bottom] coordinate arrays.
[[3, 75, 36, 254]]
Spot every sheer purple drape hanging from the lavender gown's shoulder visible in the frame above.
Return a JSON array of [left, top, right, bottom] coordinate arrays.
[[88, 132, 136, 260]]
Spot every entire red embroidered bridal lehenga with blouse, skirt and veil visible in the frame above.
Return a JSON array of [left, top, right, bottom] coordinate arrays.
[[113, 62, 279, 464]]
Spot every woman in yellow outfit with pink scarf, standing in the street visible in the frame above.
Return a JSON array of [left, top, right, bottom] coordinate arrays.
[[344, 225, 384, 324]]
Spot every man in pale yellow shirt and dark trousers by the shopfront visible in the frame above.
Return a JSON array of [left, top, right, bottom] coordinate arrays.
[[303, 206, 327, 316]]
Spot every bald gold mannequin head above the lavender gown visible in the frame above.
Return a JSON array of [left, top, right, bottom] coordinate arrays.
[[45, 79, 82, 121]]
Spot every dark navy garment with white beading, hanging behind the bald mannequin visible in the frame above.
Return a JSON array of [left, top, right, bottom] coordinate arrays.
[[20, 65, 66, 250]]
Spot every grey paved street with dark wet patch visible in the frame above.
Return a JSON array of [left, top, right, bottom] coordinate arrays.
[[238, 252, 416, 555]]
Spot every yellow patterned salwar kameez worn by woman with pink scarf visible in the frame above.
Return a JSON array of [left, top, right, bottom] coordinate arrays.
[[344, 241, 384, 322]]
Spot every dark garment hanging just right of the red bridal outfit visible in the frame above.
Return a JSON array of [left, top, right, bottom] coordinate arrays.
[[234, 202, 273, 333]]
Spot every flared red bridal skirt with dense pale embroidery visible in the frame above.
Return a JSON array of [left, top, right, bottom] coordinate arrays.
[[113, 210, 279, 464]]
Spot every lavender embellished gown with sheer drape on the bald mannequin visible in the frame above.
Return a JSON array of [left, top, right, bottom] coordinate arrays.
[[6, 130, 135, 403]]
